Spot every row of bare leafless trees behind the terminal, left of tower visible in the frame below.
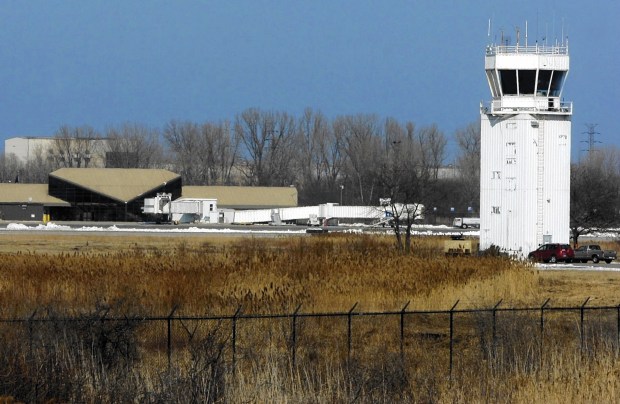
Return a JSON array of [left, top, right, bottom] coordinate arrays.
[[0, 108, 480, 215]]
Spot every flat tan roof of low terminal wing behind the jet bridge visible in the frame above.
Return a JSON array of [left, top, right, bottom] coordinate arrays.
[[182, 186, 297, 209]]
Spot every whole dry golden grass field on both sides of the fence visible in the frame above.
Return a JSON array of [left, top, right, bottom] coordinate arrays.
[[0, 233, 620, 402]]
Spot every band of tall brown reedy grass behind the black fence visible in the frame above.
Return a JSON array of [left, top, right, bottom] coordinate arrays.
[[0, 236, 539, 314]]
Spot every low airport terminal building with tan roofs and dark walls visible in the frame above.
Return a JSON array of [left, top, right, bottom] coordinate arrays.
[[0, 168, 297, 222]]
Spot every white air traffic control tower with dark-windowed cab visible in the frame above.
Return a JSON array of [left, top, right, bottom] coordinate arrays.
[[480, 35, 572, 257]]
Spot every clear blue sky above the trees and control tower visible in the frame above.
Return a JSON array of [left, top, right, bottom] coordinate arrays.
[[0, 0, 620, 161]]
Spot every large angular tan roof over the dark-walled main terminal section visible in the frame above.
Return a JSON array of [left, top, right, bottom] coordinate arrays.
[[50, 168, 181, 202]]
